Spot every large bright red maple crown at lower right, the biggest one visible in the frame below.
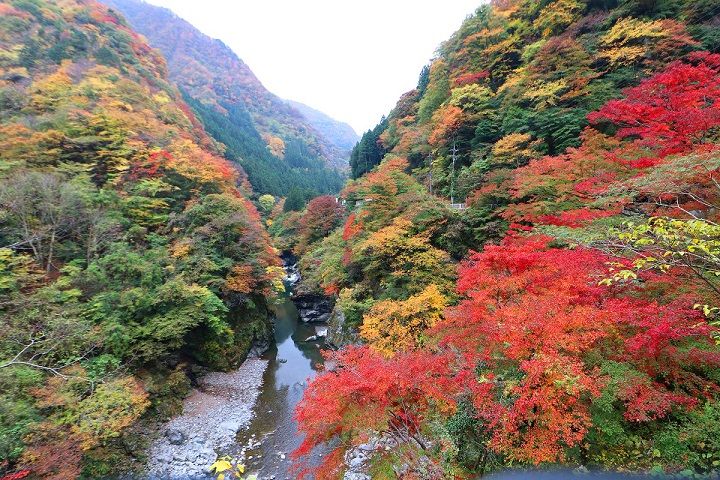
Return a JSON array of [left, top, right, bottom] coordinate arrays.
[[442, 237, 720, 463]]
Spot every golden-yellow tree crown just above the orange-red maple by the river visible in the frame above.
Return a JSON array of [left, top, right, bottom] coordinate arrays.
[[360, 285, 448, 356]]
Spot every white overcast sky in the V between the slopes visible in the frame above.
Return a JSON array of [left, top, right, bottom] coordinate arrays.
[[143, 0, 484, 133]]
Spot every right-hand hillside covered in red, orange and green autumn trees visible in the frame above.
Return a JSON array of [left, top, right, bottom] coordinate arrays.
[[290, 0, 720, 478]]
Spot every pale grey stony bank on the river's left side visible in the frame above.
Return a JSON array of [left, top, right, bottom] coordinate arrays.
[[148, 358, 267, 478]]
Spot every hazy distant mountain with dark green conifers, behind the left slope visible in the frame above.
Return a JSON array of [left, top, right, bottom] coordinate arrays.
[[105, 0, 348, 196]]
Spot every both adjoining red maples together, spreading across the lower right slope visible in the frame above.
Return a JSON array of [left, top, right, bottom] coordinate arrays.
[[298, 233, 720, 478]]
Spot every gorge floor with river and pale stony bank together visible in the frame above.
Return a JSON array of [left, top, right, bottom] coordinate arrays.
[[139, 256, 336, 479]]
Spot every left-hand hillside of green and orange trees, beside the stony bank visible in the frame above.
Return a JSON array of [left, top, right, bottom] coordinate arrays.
[[0, 0, 282, 479]]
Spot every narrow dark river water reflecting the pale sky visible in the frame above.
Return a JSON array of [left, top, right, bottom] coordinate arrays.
[[233, 290, 322, 480]]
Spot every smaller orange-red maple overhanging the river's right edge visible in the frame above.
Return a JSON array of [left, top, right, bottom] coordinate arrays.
[[296, 347, 455, 478]]
